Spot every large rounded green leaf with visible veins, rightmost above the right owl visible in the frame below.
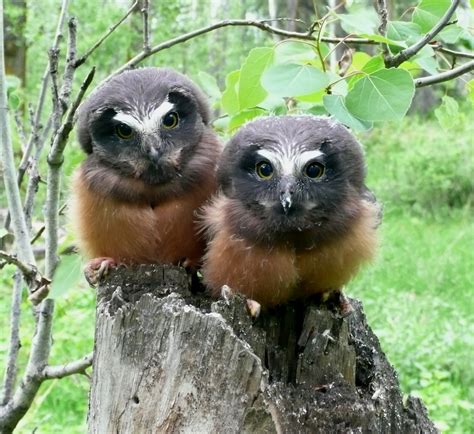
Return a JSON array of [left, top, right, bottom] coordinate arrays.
[[346, 68, 415, 122]]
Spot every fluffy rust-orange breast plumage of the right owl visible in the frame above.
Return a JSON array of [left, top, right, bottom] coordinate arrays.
[[203, 196, 379, 306]]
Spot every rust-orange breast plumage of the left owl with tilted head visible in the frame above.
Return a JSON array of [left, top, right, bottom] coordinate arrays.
[[71, 170, 216, 265]]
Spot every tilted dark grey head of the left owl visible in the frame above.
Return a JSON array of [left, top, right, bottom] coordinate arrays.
[[78, 68, 209, 185]]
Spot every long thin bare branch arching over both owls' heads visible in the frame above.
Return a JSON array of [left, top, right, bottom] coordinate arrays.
[[106, 20, 378, 79]]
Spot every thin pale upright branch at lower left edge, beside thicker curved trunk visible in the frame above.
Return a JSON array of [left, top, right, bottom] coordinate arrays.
[[0, 271, 23, 405]]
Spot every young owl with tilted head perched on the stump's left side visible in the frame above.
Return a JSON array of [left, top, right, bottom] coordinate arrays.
[[71, 68, 221, 280]]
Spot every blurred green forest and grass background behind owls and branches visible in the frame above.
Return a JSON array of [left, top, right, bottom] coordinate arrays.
[[0, 0, 474, 433]]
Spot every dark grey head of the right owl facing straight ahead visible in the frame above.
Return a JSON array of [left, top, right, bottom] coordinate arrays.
[[218, 116, 365, 247]]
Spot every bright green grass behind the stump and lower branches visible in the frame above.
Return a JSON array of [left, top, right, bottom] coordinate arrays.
[[0, 113, 474, 433]]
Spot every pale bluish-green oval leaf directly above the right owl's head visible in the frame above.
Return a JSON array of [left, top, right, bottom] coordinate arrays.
[[262, 63, 329, 97]]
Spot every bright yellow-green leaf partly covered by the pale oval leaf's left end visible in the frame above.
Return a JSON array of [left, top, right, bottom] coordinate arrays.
[[238, 47, 273, 110]]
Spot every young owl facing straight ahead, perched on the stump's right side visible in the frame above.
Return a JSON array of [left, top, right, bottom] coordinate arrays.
[[202, 116, 381, 310]]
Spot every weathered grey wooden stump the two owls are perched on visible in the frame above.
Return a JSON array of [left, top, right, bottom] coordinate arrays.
[[88, 266, 437, 434]]
